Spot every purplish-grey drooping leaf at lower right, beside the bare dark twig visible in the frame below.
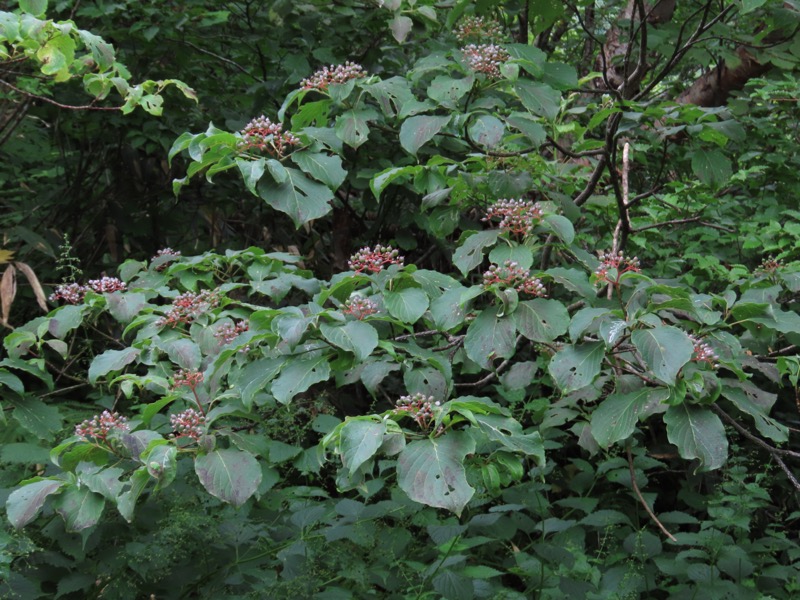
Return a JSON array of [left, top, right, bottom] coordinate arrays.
[[664, 403, 728, 471]]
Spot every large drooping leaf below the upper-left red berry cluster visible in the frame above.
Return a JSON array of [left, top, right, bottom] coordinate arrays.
[[258, 168, 333, 228]]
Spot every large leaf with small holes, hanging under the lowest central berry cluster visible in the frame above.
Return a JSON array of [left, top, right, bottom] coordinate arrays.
[[397, 431, 475, 516]]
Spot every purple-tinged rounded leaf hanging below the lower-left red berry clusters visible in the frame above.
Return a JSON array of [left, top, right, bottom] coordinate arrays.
[[194, 448, 262, 508]]
